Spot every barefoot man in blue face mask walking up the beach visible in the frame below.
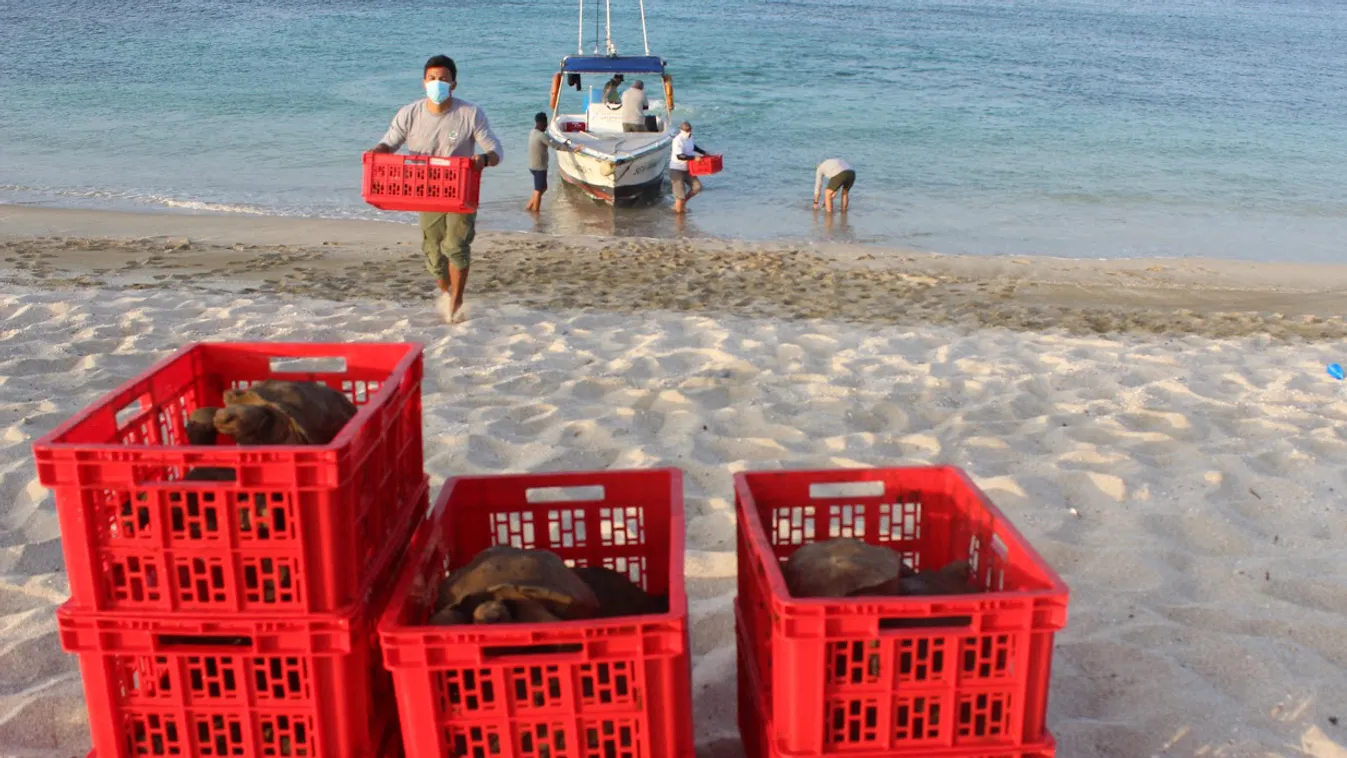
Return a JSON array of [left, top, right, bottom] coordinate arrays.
[[374, 55, 505, 323]]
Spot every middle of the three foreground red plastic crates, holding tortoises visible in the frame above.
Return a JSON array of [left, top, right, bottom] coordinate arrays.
[[380, 469, 694, 758]]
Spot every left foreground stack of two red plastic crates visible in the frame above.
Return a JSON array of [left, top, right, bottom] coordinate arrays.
[[34, 343, 428, 758]]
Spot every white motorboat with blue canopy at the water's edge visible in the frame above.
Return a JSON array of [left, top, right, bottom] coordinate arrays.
[[547, 0, 676, 205]]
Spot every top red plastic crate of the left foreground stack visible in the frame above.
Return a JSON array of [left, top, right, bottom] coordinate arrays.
[[34, 343, 424, 614]]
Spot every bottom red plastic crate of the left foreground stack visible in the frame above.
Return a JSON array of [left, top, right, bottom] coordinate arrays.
[[57, 605, 397, 758]]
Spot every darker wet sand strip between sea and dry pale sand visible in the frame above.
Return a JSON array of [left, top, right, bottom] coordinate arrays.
[[0, 206, 1347, 339]]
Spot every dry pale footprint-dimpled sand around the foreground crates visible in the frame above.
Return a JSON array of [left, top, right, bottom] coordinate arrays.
[[0, 207, 1347, 758]]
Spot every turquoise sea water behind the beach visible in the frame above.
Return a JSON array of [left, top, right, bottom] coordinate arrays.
[[0, 0, 1347, 263]]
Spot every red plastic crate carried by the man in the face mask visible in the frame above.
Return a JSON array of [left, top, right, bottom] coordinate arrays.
[[361, 152, 482, 213]]
